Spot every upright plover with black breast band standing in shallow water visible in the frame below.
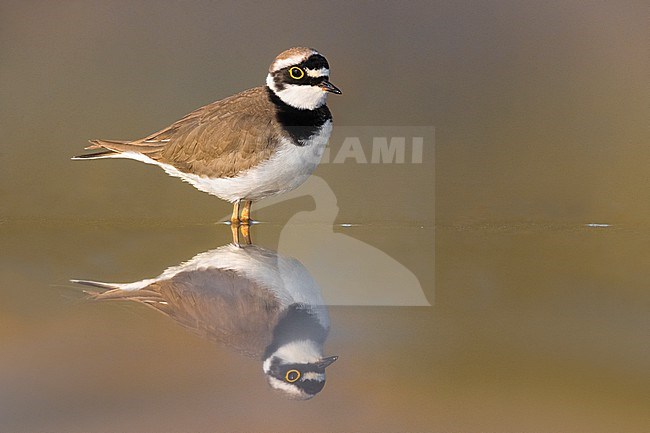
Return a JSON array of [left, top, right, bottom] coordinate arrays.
[[72, 47, 341, 224]]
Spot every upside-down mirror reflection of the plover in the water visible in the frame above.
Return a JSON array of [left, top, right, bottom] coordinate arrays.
[[72, 244, 338, 399]]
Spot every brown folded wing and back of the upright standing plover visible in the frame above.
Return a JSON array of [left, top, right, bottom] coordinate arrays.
[[87, 87, 285, 177]]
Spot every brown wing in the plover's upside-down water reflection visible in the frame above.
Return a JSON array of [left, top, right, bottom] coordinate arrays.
[[94, 268, 280, 358]]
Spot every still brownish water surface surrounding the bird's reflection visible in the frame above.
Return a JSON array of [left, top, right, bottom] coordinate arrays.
[[0, 218, 649, 432]]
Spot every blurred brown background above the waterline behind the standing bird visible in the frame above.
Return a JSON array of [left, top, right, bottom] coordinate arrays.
[[0, 1, 650, 223]]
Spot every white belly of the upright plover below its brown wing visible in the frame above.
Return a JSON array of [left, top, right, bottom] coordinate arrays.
[[115, 121, 332, 202]]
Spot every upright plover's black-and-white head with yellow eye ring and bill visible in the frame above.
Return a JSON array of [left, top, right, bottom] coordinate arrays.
[[266, 47, 341, 110]]
